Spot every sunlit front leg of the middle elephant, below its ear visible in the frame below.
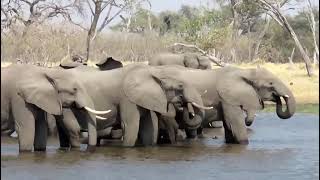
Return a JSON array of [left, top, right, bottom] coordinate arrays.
[[120, 100, 140, 147]]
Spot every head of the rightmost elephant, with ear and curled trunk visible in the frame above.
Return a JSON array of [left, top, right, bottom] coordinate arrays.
[[217, 68, 296, 125]]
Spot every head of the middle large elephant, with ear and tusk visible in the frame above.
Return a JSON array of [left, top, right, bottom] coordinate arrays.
[[124, 69, 211, 127]]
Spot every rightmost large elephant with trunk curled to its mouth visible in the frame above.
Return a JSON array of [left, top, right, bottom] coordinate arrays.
[[152, 66, 296, 144]]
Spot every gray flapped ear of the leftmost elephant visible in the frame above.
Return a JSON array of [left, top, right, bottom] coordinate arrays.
[[17, 73, 62, 115]]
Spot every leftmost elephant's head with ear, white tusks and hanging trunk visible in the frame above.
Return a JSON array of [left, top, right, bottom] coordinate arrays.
[[17, 69, 110, 145]]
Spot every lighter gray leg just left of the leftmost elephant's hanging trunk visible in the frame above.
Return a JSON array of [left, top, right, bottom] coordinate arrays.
[[62, 108, 80, 148]]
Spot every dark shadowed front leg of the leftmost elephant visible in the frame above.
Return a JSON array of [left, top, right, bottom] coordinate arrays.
[[34, 109, 48, 151]]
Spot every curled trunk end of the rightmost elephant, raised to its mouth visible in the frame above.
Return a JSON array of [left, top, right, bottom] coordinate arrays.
[[275, 92, 296, 119]]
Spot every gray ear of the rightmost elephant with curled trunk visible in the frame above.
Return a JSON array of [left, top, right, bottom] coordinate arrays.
[[217, 76, 262, 109]]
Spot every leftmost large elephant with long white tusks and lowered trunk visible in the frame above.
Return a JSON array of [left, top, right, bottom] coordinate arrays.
[[1, 65, 110, 152]]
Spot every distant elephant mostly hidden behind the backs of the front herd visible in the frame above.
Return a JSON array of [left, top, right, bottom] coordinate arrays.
[[149, 53, 211, 69]]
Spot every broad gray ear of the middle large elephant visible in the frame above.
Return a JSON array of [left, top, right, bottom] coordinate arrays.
[[123, 69, 168, 113]]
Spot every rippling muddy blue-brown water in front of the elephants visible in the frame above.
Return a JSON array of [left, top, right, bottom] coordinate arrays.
[[1, 113, 319, 180]]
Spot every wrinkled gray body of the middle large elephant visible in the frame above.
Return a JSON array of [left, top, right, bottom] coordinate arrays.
[[40, 64, 202, 147]]
